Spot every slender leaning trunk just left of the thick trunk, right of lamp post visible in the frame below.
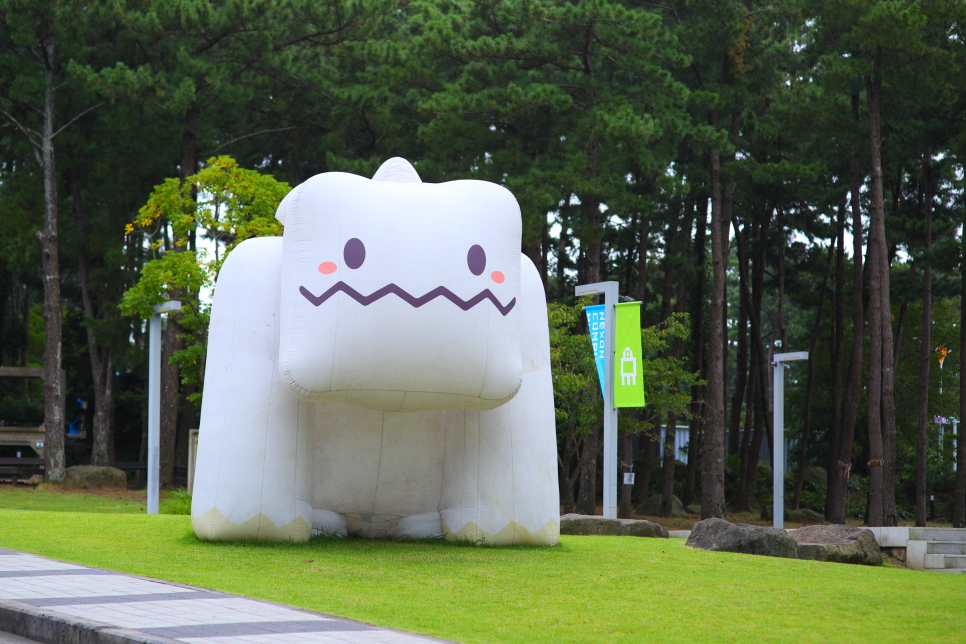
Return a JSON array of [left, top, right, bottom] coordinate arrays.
[[826, 94, 865, 524]]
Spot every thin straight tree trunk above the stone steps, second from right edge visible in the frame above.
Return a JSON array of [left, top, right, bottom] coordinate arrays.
[[920, 158, 932, 526]]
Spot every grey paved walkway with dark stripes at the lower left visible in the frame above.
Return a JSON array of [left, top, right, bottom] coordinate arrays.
[[0, 548, 454, 644]]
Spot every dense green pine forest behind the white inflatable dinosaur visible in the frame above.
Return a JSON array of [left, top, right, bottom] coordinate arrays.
[[0, 0, 966, 526]]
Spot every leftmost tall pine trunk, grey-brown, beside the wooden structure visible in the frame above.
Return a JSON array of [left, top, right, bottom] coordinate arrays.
[[40, 30, 67, 483]]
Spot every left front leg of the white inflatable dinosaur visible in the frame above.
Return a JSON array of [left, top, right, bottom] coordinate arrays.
[[191, 237, 313, 541]]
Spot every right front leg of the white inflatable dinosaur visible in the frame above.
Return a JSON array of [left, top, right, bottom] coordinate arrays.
[[442, 256, 560, 546]]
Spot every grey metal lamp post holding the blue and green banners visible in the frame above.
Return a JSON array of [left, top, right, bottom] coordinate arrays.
[[574, 282, 618, 519]]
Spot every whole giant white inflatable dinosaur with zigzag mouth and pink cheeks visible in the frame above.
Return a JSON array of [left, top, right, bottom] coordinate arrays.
[[192, 159, 559, 545]]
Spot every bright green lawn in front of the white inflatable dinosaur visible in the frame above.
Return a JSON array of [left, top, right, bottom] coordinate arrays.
[[0, 511, 966, 643]]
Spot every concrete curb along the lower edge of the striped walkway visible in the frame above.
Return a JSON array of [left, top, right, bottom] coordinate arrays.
[[0, 599, 184, 644]]
